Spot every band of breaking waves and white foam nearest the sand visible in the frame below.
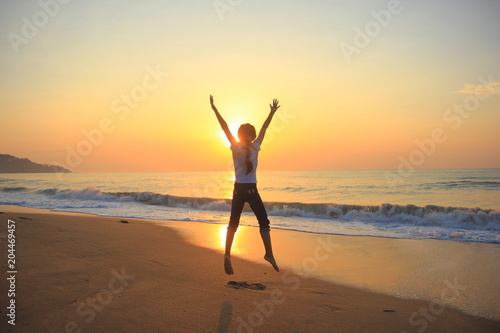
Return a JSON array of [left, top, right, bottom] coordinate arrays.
[[0, 182, 500, 243]]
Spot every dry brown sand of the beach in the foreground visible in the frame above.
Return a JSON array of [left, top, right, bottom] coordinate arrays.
[[0, 206, 500, 332]]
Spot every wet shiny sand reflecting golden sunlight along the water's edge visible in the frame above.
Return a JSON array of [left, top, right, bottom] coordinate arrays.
[[0, 205, 500, 321]]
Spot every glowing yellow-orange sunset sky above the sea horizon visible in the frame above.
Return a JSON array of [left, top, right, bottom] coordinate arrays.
[[0, 0, 500, 172]]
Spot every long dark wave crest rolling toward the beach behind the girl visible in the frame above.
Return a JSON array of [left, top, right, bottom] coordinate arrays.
[[25, 187, 500, 231]]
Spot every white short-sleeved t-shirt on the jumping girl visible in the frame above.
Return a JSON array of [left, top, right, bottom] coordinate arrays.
[[231, 140, 260, 183]]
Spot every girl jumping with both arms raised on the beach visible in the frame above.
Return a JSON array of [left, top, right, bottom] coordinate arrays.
[[210, 95, 280, 275]]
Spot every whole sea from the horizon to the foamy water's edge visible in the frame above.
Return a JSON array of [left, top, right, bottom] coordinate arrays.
[[0, 169, 500, 243]]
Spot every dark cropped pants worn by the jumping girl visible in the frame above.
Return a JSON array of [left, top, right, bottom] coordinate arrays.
[[227, 183, 270, 232]]
